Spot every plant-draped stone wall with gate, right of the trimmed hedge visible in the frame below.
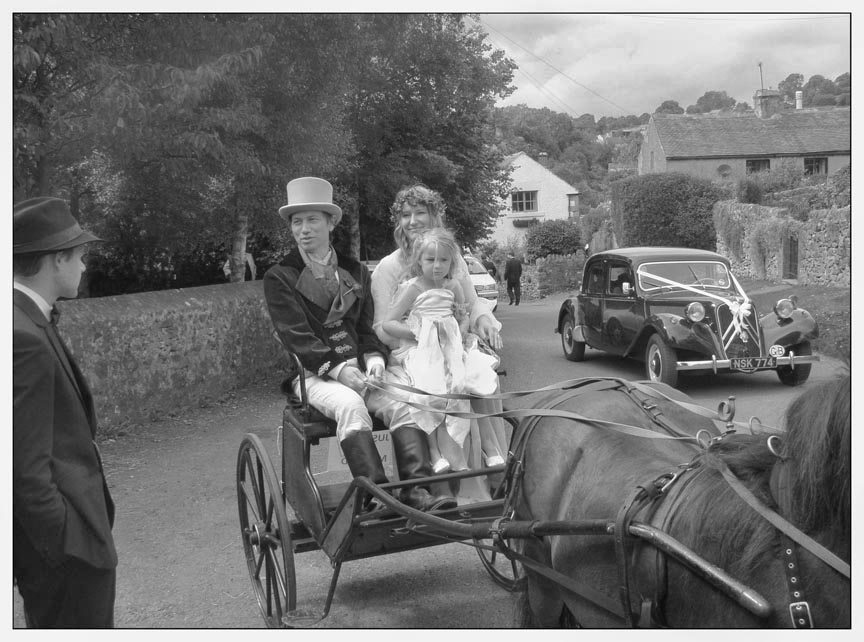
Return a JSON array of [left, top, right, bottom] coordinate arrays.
[[714, 201, 852, 287]]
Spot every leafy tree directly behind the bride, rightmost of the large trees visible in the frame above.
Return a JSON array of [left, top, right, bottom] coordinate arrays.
[[341, 14, 514, 257]]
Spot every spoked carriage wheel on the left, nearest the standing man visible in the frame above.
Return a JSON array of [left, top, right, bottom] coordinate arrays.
[[237, 434, 297, 628]]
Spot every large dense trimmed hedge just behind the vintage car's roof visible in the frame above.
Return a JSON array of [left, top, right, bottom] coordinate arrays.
[[611, 172, 722, 250]]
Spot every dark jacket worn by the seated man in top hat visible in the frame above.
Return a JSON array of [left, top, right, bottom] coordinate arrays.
[[264, 249, 388, 378]]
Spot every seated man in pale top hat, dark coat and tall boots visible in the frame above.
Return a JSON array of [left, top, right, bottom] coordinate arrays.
[[264, 177, 456, 510]]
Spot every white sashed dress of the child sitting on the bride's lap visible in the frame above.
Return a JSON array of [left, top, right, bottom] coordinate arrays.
[[391, 279, 498, 460]]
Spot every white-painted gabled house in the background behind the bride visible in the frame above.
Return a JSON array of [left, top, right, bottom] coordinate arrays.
[[488, 152, 579, 245]]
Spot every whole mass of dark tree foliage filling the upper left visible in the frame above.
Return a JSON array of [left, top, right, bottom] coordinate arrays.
[[13, 14, 513, 294]]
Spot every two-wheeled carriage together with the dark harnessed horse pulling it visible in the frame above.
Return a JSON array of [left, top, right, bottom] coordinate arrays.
[[237, 350, 851, 628]]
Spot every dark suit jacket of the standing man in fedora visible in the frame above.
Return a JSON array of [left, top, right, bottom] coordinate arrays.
[[12, 290, 117, 569]]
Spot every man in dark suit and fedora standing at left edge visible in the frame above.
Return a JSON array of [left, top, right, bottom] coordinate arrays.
[[12, 197, 117, 628]]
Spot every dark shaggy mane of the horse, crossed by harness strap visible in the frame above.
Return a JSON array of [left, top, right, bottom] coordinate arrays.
[[676, 375, 852, 573]]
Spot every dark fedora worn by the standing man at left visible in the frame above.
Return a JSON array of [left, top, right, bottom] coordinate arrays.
[[12, 196, 102, 254]]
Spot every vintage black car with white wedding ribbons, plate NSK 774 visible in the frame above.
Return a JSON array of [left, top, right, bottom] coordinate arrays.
[[555, 247, 819, 386]]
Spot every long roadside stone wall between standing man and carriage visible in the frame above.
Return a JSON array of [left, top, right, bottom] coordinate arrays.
[[57, 281, 285, 430]]
